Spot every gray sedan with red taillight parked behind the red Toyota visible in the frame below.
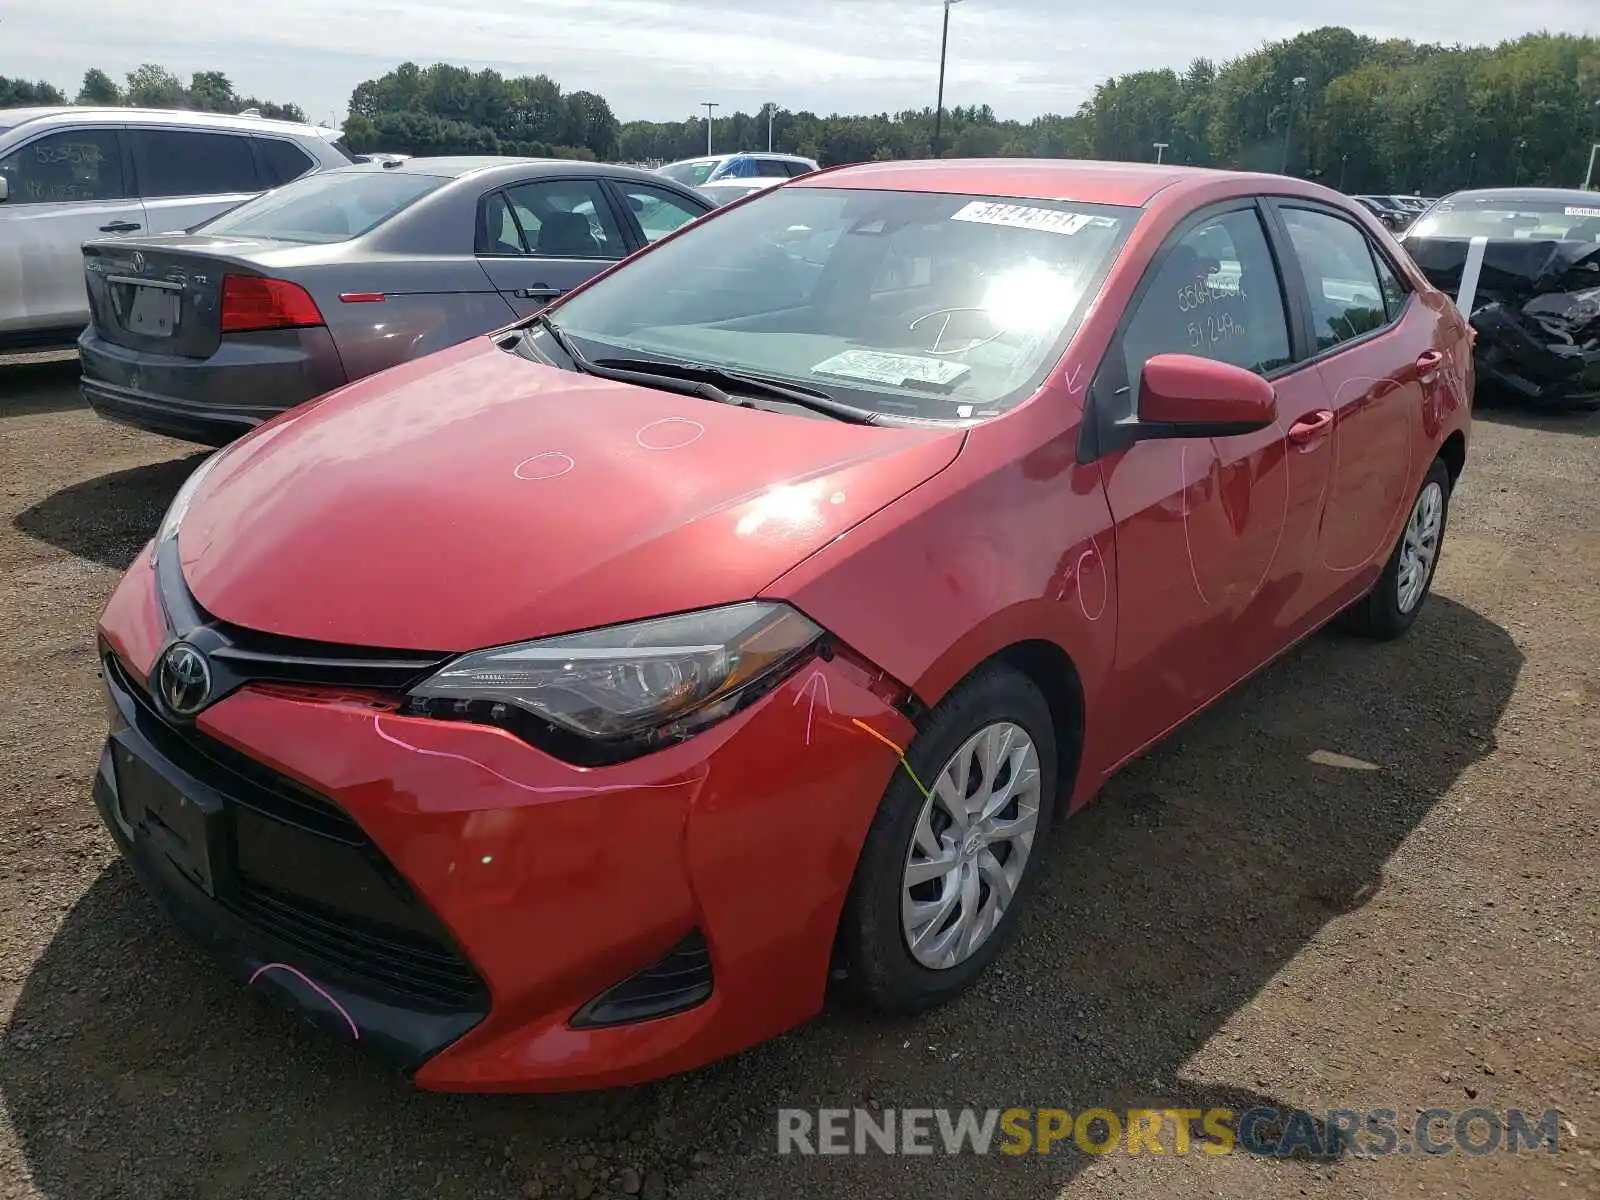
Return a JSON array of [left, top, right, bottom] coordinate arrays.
[[78, 158, 712, 445]]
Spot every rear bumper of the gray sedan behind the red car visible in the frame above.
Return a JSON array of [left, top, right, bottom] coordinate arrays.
[[78, 325, 346, 446]]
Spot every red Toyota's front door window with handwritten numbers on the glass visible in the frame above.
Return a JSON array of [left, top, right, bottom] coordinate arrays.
[[1122, 208, 1291, 384]]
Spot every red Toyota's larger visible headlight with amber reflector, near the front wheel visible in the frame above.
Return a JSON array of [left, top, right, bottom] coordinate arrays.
[[410, 602, 822, 762]]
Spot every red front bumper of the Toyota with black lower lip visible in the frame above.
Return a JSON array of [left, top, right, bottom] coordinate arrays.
[[96, 557, 910, 1091]]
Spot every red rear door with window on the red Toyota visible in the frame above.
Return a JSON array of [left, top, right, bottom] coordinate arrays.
[[1274, 200, 1443, 590]]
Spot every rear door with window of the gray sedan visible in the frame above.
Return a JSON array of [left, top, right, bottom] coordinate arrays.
[[477, 179, 634, 317]]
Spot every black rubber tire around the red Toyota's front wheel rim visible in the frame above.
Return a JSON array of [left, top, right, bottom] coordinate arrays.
[[838, 664, 1059, 1014]]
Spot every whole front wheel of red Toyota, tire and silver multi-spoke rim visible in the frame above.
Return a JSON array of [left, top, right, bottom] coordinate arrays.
[[840, 664, 1058, 1013]]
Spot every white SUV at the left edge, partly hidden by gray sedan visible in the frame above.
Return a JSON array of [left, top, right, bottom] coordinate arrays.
[[0, 107, 355, 350]]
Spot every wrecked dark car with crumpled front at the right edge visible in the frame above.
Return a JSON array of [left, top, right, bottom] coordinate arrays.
[[1403, 187, 1600, 408]]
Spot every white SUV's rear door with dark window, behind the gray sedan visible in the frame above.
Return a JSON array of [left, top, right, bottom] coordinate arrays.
[[126, 128, 272, 234]]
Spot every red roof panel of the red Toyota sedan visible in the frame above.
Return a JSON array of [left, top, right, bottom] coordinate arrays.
[[789, 158, 1235, 208]]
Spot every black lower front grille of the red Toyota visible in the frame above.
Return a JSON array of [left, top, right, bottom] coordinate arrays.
[[104, 653, 488, 1013]]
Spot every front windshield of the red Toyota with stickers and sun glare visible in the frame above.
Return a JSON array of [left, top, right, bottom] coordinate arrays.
[[550, 187, 1139, 421]]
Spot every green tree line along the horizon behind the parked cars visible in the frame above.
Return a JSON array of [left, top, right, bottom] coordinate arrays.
[[0, 27, 1600, 195]]
